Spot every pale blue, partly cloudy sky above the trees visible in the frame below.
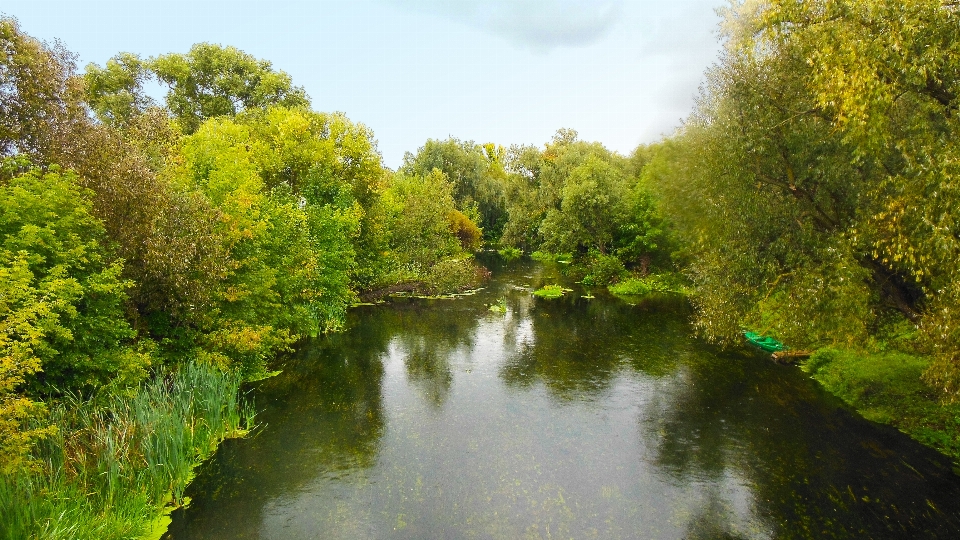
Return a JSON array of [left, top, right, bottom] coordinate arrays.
[[0, 0, 726, 168]]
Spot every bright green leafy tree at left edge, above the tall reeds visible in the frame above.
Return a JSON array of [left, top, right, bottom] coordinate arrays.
[[0, 162, 150, 395]]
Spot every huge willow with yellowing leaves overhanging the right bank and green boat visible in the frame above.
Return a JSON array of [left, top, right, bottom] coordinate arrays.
[[645, 0, 960, 392]]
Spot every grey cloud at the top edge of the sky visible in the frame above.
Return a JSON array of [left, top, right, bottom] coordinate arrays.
[[383, 0, 623, 50]]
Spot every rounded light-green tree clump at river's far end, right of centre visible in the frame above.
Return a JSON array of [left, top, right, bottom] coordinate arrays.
[[502, 130, 673, 281]]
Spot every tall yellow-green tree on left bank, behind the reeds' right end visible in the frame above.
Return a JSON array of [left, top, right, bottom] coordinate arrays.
[[168, 107, 381, 372]]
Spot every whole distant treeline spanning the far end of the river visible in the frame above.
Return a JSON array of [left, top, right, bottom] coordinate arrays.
[[400, 129, 681, 286]]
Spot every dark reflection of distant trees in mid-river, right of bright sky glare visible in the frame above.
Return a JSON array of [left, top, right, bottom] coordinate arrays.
[[501, 297, 689, 400]]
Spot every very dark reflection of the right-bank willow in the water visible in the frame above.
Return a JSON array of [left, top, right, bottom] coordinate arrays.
[[642, 352, 960, 538]]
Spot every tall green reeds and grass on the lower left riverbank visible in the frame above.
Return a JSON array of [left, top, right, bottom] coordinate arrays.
[[0, 363, 254, 540]]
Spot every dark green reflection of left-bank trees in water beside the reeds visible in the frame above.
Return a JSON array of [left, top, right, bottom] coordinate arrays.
[[167, 306, 394, 539]]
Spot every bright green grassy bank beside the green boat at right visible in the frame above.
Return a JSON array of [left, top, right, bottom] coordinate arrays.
[[801, 348, 960, 463]]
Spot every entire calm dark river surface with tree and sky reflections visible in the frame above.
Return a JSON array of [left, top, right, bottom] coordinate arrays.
[[166, 263, 960, 539]]
